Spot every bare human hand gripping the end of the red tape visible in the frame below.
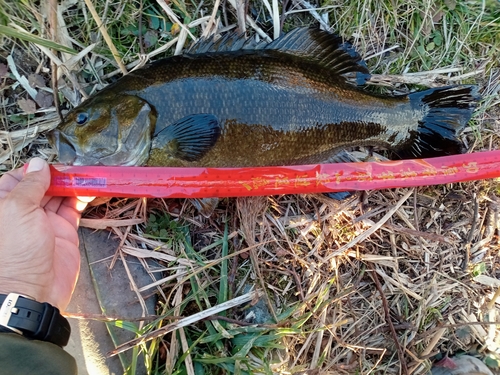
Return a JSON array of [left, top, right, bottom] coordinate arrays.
[[0, 158, 91, 311]]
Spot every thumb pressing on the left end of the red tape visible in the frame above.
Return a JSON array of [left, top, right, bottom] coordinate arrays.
[[9, 158, 50, 208]]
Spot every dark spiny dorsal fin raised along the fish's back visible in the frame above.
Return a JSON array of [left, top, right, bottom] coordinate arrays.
[[186, 27, 370, 85]]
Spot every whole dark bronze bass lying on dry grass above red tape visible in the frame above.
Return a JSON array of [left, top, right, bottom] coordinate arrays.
[[48, 28, 480, 213]]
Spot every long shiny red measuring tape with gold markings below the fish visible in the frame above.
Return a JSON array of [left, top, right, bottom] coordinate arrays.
[[39, 150, 500, 198]]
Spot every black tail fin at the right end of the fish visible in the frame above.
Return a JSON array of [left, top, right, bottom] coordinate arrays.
[[398, 85, 480, 158]]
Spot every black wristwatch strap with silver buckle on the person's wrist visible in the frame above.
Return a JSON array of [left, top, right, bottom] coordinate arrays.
[[0, 293, 71, 347]]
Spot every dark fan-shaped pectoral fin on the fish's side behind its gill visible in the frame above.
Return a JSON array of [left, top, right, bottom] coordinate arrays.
[[151, 114, 221, 161]]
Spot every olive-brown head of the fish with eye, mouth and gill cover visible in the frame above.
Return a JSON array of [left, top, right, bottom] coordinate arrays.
[[47, 92, 156, 166]]
